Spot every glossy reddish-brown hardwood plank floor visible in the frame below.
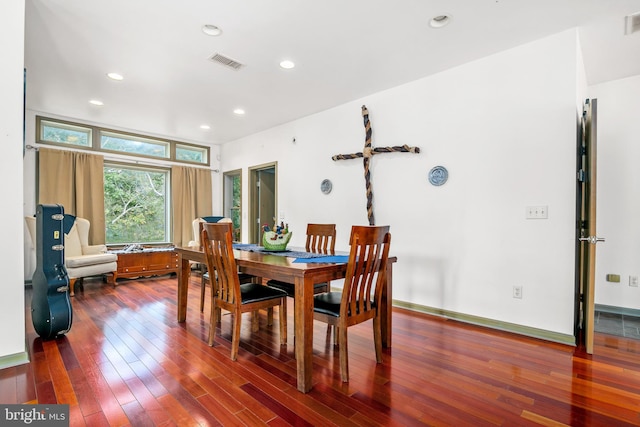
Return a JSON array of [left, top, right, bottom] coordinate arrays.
[[0, 276, 640, 427]]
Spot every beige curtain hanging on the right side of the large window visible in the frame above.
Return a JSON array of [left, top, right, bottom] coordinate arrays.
[[171, 166, 212, 246]]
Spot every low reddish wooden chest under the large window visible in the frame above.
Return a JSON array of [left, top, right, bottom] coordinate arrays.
[[110, 248, 180, 278]]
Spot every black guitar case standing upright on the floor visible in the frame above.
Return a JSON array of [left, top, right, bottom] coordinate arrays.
[[31, 205, 73, 339]]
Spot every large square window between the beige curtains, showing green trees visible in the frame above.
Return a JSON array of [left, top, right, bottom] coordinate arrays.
[[104, 163, 171, 244]]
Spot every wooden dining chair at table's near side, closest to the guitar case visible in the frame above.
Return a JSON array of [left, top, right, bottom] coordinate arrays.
[[201, 223, 287, 360]]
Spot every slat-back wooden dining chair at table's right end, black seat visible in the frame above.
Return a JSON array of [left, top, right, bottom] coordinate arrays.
[[313, 225, 391, 382]]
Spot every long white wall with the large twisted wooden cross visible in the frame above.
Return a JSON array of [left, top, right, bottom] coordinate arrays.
[[222, 31, 582, 335]]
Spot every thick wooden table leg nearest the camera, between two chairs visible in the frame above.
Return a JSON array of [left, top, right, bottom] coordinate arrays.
[[294, 277, 313, 393]]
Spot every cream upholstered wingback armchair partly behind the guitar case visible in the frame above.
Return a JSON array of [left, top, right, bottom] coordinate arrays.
[[25, 217, 118, 296]]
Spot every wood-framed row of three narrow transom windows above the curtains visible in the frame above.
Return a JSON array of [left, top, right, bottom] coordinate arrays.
[[36, 116, 210, 166]]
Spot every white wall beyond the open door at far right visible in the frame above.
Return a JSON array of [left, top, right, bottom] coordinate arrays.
[[589, 76, 640, 309]]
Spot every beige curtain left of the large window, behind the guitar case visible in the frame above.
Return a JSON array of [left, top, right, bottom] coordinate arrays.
[[38, 148, 105, 245]]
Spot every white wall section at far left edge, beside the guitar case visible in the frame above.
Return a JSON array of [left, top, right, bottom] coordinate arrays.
[[0, 1, 27, 368]]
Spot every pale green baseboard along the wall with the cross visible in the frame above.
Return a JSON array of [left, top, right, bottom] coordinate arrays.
[[393, 300, 576, 346]]
